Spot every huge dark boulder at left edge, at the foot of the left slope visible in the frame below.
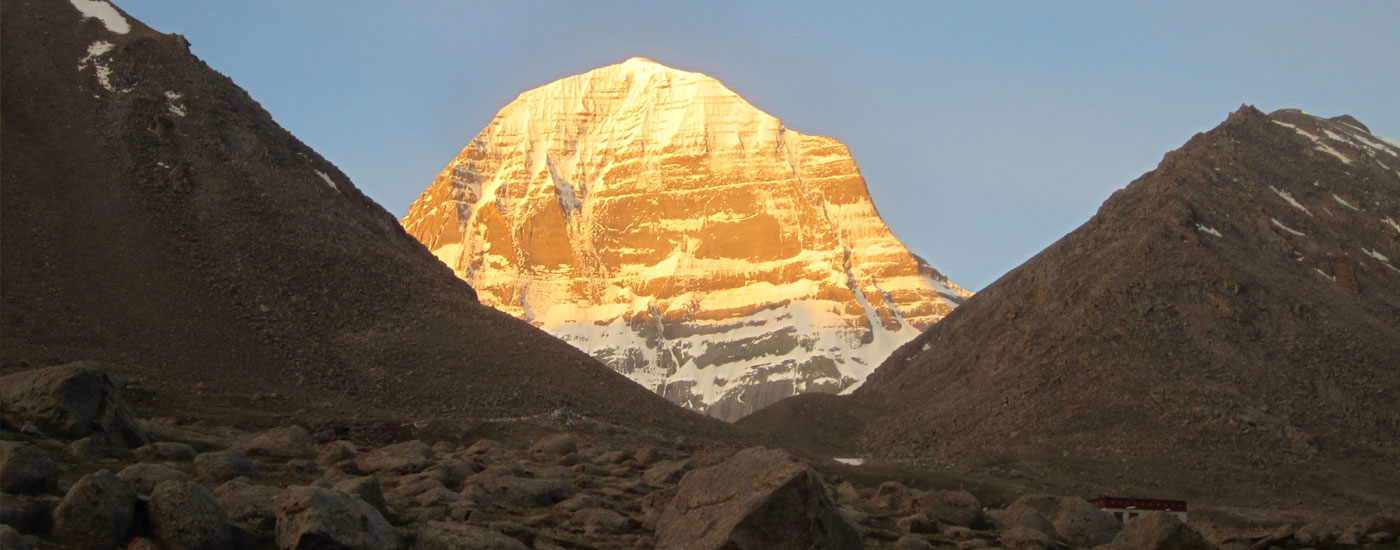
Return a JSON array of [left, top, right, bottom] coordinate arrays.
[[0, 361, 146, 446]]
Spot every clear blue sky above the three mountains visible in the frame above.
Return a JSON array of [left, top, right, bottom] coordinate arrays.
[[116, 0, 1400, 290]]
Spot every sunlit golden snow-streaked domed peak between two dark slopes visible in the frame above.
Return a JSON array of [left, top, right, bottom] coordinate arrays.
[[402, 57, 970, 420]]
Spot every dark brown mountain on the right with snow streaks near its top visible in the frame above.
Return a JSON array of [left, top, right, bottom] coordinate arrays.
[[741, 106, 1400, 505]]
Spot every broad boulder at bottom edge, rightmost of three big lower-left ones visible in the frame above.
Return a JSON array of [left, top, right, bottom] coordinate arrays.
[[277, 486, 399, 550]]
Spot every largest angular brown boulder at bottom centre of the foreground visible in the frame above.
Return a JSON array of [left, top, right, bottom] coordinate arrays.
[[657, 446, 862, 550]]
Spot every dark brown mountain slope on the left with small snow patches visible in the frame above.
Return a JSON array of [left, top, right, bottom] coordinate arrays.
[[0, 0, 728, 432]]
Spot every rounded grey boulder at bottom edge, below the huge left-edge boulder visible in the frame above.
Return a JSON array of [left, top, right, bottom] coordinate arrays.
[[52, 470, 136, 549]]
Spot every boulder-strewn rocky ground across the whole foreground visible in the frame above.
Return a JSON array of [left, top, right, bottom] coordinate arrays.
[[0, 362, 1400, 550]]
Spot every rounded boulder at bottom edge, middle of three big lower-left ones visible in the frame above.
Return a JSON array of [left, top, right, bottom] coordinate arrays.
[[148, 480, 234, 550]]
